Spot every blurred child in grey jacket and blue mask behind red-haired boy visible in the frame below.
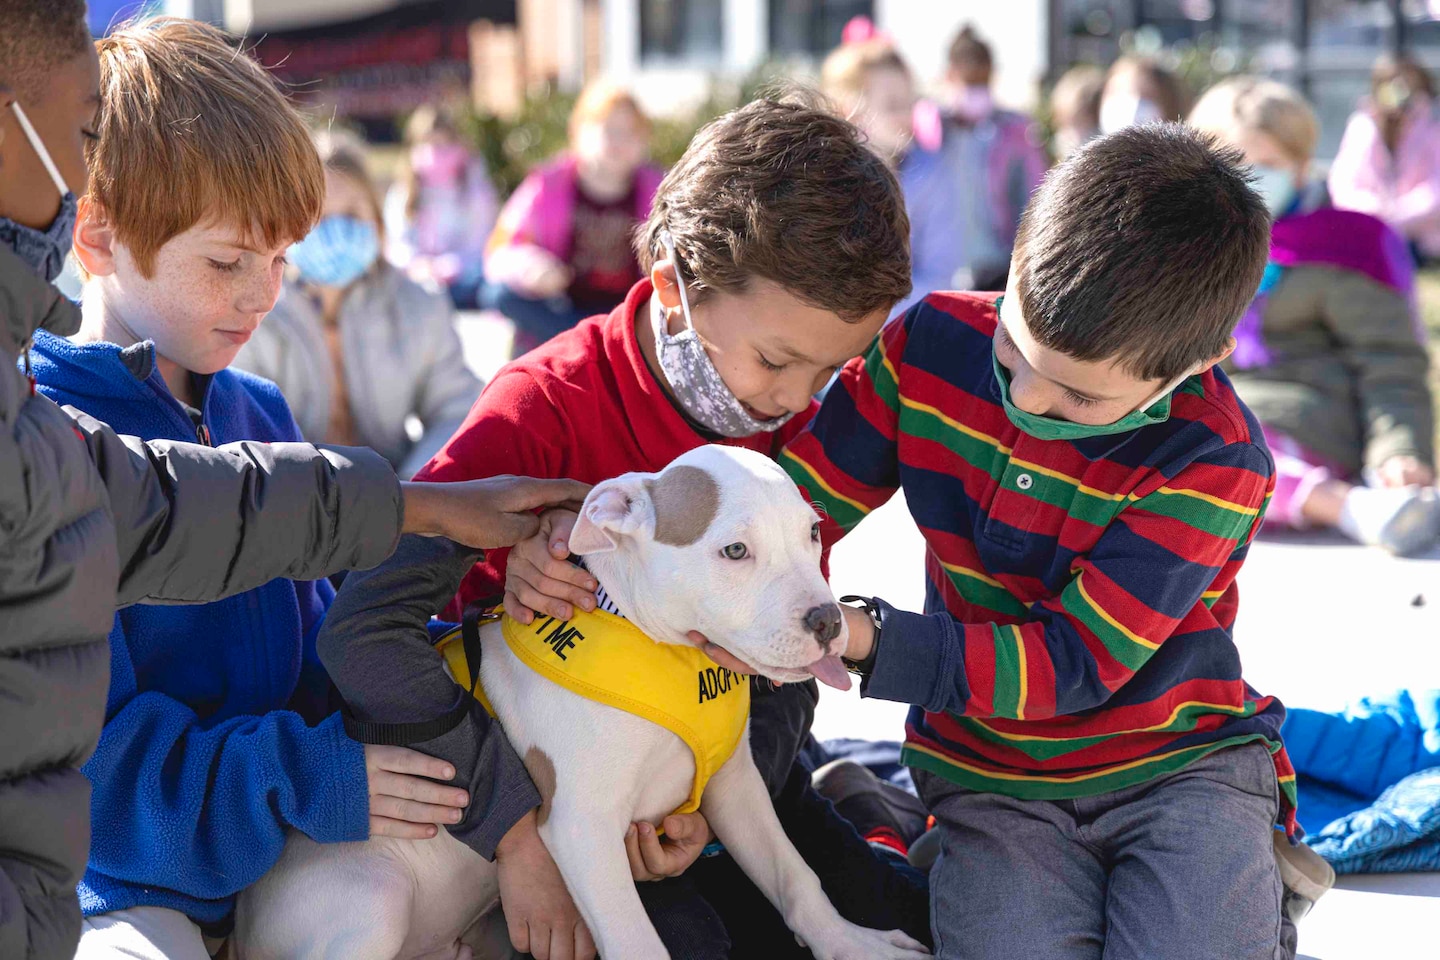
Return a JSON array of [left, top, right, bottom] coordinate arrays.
[[235, 132, 481, 479]]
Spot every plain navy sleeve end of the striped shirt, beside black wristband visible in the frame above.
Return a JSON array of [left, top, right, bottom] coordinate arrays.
[[860, 599, 969, 712]]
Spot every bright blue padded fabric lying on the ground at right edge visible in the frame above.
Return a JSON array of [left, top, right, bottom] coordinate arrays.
[[1282, 689, 1440, 874]]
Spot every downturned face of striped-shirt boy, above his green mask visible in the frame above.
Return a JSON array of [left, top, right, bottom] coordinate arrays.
[[995, 285, 1165, 426]]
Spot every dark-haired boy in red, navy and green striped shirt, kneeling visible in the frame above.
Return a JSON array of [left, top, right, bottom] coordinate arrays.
[[782, 125, 1295, 960]]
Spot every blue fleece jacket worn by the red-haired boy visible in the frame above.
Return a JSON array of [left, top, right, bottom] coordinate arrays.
[[32, 331, 369, 923]]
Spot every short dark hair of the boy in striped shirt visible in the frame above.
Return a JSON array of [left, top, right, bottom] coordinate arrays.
[[1012, 124, 1270, 380]]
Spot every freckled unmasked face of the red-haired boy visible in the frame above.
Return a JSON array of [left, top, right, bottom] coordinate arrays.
[[105, 223, 298, 374]]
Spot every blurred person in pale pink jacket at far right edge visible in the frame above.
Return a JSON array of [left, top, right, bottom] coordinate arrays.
[[1329, 56, 1440, 262]]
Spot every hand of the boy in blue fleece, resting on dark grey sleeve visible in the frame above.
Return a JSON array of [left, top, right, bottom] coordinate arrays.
[[364, 744, 469, 841]]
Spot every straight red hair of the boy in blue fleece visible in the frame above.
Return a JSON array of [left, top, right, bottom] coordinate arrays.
[[89, 17, 325, 276]]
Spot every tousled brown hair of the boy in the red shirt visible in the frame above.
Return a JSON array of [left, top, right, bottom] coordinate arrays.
[[635, 92, 910, 322]]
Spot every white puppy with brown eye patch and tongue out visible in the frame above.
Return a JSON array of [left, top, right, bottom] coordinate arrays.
[[236, 446, 926, 960]]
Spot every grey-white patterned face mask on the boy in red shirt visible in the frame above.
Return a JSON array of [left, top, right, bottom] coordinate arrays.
[[649, 230, 795, 438]]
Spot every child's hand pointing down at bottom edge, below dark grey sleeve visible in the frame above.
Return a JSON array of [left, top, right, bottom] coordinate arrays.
[[495, 810, 595, 960]]
